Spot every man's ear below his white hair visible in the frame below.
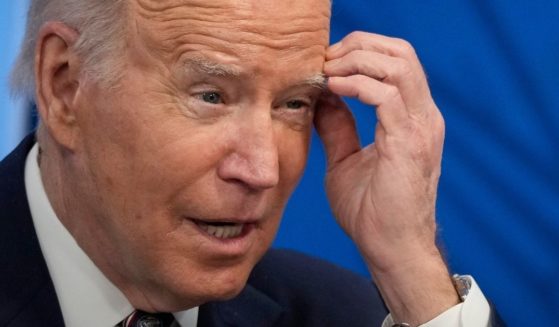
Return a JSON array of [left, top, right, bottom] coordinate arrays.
[[35, 22, 80, 150]]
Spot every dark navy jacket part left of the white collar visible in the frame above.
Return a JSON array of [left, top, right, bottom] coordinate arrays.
[[0, 135, 64, 327]]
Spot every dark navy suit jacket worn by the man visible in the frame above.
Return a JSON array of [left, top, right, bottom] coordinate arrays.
[[0, 136, 506, 327]]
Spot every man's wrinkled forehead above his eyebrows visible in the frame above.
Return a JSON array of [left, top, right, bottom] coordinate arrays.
[[132, 0, 330, 72]]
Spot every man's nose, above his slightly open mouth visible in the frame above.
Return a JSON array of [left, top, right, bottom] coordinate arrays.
[[217, 112, 279, 190]]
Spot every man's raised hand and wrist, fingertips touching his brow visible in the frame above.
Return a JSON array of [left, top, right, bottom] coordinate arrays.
[[315, 32, 458, 324]]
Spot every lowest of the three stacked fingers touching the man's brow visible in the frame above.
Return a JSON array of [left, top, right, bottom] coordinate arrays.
[[328, 75, 409, 133]]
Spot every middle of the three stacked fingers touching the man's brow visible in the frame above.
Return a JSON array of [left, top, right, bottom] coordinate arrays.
[[324, 50, 433, 113]]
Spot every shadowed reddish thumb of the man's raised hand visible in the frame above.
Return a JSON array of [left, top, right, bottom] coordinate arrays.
[[314, 93, 361, 170]]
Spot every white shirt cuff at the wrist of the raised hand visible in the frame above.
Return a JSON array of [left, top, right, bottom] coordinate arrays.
[[382, 276, 491, 327]]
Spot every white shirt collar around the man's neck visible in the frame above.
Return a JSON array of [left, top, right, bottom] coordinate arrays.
[[25, 144, 198, 327]]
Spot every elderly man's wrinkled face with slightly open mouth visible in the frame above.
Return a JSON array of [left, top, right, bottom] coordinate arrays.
[[70, 0, 330, 310]]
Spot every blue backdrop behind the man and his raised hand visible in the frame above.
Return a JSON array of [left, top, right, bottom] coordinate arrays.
[[0, 0, 559, 326]]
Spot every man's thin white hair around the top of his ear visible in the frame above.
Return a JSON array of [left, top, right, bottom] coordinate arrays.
[[11, 0, 127, 100]]
